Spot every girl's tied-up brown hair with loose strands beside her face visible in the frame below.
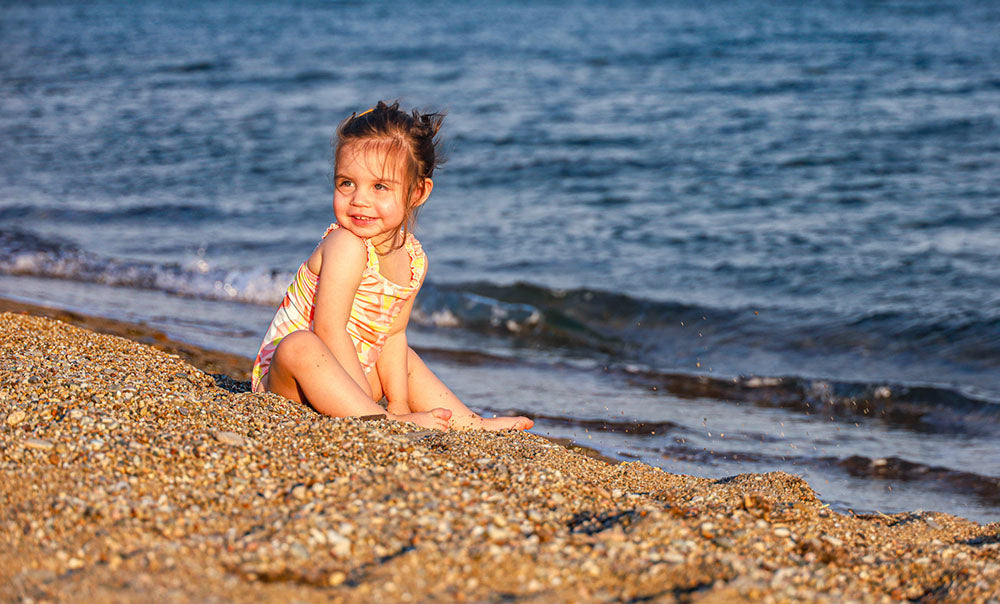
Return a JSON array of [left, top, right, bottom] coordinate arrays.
[[333, 101, 445, 245]]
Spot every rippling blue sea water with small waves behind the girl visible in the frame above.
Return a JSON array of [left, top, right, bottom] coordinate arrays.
[[0, 0, 1000, 520]]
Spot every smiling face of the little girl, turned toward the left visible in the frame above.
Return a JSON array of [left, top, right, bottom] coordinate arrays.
[[333, 144, 407, 251]]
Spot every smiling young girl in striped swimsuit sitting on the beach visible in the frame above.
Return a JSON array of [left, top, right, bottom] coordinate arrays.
[[253, 101, 534, 430]]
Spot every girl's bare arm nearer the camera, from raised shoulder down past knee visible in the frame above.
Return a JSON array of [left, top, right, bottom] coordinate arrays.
[[309, 229, 372, 399]]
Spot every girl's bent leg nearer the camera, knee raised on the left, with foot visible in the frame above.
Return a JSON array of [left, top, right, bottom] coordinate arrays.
[[265, 331, 451, 429]]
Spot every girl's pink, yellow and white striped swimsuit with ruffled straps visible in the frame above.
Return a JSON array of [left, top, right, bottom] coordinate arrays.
[[252, 224, 427, 392]]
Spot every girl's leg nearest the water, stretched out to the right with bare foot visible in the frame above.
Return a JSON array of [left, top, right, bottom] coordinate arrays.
[[406, 348, 535, 430]]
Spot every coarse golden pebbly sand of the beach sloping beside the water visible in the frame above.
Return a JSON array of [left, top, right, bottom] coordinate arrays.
[[0, 313, 1000, 602]]
